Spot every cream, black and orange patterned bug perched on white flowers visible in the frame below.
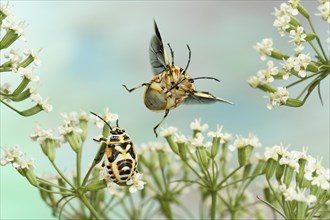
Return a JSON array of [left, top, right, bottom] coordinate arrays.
[[91, 112, 138, 185]]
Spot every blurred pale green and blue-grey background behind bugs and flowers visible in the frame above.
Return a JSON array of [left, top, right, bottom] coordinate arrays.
[[0, 0, 329, 219]]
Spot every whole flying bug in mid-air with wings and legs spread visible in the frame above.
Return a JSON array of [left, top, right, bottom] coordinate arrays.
[[123, 20, 233, 137]]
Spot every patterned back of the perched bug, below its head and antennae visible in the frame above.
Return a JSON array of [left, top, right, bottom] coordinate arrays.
[[105, 138, 137, 185]]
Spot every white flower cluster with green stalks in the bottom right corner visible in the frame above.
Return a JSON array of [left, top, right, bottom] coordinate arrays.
[[260, 145, 330, 219]]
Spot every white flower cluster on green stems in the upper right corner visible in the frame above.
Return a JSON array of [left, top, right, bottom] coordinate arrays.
[[248, 0, 330, 109]]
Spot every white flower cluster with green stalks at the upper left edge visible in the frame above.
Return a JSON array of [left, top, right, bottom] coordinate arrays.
[[0, 2, 53, 116]]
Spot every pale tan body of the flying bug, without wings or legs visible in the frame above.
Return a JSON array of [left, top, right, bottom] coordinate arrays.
[[144, 64, 195, 111]]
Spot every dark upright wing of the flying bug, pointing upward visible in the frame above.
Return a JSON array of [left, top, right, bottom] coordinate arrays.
[[149, 20, 167, 75]]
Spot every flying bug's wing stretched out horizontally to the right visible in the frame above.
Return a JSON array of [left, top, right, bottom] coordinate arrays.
[[183, 91, 234, 105]]
